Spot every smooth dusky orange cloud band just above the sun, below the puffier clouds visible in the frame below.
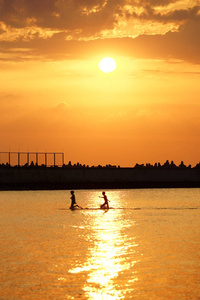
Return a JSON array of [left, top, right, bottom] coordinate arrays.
[[1, 21, 200, 64]]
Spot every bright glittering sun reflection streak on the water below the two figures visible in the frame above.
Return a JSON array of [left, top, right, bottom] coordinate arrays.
[[69, 195, 138, 300]]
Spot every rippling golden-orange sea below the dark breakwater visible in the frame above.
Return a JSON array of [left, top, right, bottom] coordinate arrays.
[[0, 188, 200, 300]]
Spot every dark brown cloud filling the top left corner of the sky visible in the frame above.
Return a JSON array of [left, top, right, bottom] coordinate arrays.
[[0, 0, 121, 34]]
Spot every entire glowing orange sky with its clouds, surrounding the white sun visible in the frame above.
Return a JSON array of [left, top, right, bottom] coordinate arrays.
[[0, 0, 200, 166]]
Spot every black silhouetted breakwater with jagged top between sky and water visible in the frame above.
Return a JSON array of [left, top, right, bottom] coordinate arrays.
[[0, 164, 200, 191]]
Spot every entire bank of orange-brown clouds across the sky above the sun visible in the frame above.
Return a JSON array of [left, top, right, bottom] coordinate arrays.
[[0, 0, 200, 63]]
